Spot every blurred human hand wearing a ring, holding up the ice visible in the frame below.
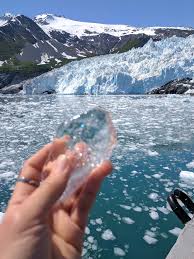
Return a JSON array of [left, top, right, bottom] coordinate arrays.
[[0, 138, 112, 259]]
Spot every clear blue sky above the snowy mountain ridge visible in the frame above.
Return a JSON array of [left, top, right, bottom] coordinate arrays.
[[0, 0, 194, 27]]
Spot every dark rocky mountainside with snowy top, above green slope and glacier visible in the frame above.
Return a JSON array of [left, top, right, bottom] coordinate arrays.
[[0, 13, 194, 64]]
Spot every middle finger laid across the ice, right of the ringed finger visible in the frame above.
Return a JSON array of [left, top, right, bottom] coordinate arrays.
[[26, 154, 75, 215]]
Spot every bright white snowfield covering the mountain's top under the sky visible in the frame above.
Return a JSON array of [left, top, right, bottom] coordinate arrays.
[[34, 14, 192, 38]]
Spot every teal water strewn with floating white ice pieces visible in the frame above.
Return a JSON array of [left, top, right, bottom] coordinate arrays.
[[0, 96, 194, 259]]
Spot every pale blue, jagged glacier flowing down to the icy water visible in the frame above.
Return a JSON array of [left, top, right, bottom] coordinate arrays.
[[22, 35, 194, 95]]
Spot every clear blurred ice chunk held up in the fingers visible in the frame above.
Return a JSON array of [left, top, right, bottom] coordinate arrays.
[[44, 108, 116, 199]]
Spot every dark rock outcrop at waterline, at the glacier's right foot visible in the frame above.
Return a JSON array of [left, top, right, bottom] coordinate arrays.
[[148, 78, 194, 94]]
